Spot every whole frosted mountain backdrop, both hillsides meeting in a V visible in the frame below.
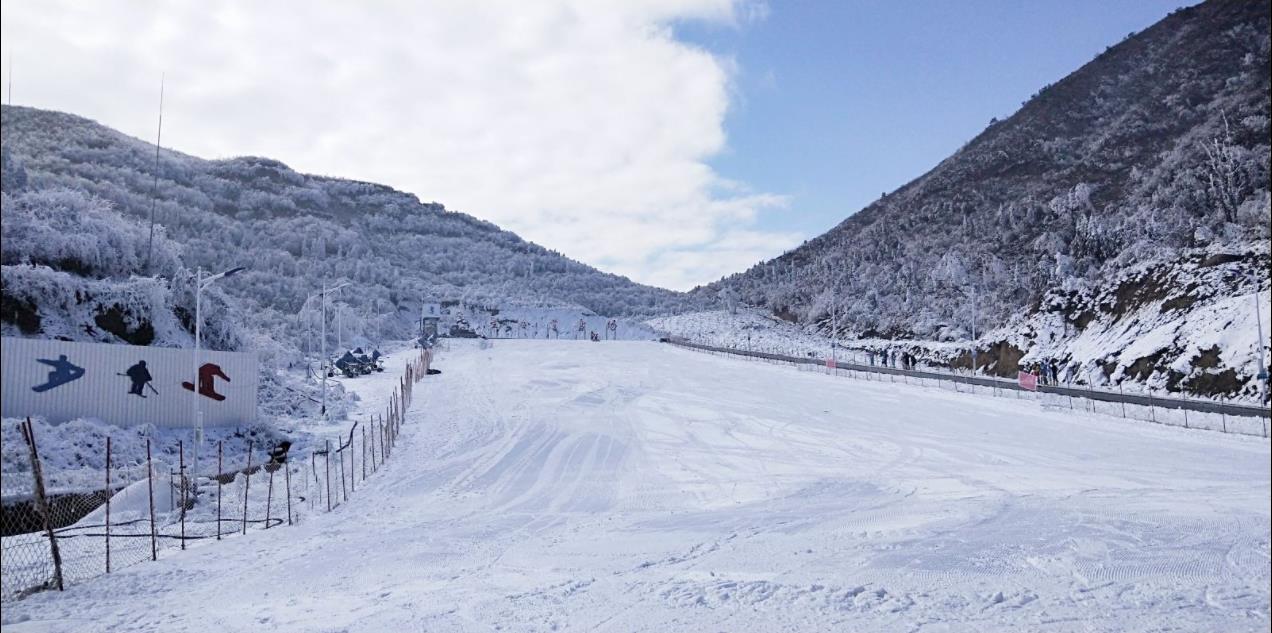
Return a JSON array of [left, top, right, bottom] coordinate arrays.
[[0, 3, 1272, 404]]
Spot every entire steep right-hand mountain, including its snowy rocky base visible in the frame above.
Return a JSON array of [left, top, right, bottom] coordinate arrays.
[[697, 1, 1272, 394]]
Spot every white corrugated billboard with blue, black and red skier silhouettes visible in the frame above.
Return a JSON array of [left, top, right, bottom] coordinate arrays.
[[0, 337, 258, 427]]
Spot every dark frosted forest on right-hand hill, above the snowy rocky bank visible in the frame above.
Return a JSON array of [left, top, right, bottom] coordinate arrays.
[[700, 1, 1269, 339]]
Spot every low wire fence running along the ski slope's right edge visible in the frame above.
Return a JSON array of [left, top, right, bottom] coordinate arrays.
[[668, 339, 1269, 437]]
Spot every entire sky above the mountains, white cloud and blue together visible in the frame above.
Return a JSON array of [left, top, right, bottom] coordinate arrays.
[[0, 0, 1180, 290]]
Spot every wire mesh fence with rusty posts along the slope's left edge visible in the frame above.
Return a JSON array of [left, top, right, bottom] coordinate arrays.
[[0, 350, 432, 602]]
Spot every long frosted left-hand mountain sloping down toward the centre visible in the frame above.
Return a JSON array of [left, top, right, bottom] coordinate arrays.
[[0, 106, 701, 348]]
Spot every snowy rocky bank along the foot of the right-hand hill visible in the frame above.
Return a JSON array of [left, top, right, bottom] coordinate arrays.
[[645, 306, 1272, 404]]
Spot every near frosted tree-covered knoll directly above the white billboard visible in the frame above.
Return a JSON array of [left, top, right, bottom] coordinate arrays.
[[0, 188, 244, 350]]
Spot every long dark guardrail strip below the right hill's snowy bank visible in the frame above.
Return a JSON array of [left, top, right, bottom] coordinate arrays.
[[663, 337, 1272, 418]]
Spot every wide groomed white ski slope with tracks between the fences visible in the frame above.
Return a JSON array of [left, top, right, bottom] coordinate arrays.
[[4, 341, 1272, 633]]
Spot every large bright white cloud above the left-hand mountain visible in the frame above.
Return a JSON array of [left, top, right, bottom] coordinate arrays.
[[4, 0, 799, 289]]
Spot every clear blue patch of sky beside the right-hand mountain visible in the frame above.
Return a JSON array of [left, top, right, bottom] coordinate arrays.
[[675, 0, 1191, 238]]
